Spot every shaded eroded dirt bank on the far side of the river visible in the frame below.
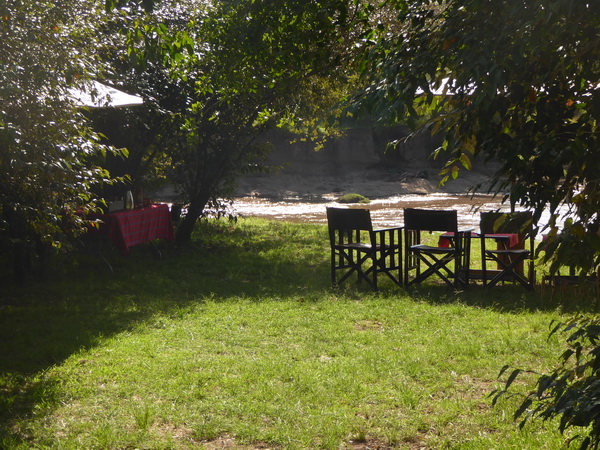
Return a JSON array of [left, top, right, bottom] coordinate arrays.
[[236, 127, 497, 199]]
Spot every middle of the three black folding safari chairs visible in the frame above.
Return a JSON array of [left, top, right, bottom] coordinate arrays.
[[404, 208, 471, 286]]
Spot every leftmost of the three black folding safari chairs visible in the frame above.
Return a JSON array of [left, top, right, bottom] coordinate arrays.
[[327, 208, 402, 290]]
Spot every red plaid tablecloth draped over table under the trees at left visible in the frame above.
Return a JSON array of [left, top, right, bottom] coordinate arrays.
[[91, 204, 175, 253]]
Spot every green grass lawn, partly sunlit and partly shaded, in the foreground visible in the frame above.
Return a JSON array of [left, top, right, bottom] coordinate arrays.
[[0, 219, 595, 449]]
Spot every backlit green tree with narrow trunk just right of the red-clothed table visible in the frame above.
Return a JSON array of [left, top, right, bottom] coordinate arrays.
[[108, 0, 368, 241]]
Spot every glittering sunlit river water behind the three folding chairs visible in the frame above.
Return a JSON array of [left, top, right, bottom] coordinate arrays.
[[233, 194, 548, 229]]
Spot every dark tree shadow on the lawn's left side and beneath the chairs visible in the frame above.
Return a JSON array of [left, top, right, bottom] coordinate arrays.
[[0, 217, 595, 446]]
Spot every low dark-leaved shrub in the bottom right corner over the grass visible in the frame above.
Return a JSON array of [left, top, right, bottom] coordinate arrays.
[[493, 317, 600, 448]]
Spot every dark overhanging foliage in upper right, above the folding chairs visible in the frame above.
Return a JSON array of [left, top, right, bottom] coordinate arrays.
[[351, 0, 600, 273]]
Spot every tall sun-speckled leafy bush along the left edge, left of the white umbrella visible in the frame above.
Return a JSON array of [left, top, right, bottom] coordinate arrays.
[[0, 0, 120, 276]]
